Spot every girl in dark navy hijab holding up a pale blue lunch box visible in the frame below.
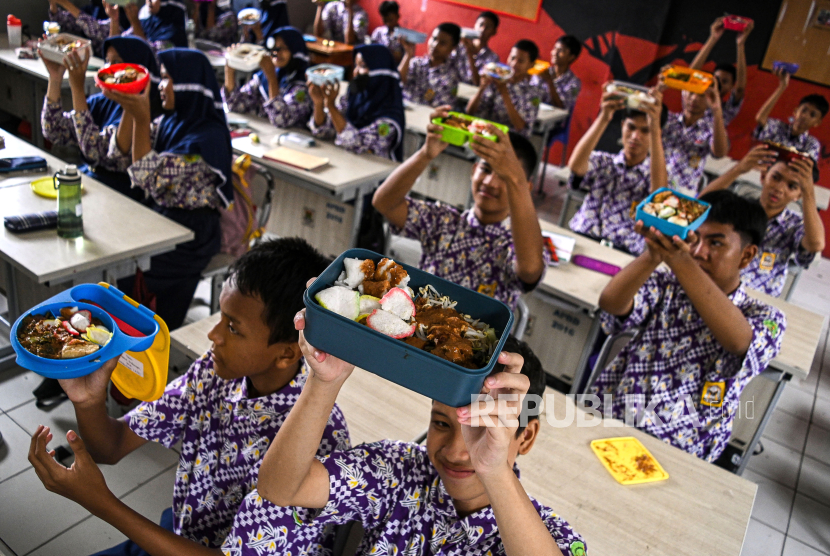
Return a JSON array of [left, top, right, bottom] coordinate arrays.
[[308, 44, 405, 161]]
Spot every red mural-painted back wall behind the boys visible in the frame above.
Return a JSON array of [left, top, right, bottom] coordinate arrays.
[[360, 0, 830, 257]]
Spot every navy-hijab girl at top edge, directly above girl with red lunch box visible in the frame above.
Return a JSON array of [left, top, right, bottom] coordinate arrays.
[[122, 0, 187, 52]]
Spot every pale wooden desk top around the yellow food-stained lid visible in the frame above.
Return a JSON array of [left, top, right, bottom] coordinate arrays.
[[528, 388, 757, 556]]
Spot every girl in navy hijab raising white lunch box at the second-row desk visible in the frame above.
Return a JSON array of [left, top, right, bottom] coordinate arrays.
[[222, 27, 312, 127]]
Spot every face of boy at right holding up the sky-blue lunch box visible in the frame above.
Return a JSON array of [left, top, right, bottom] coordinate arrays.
[[691, 220, 758, 294]]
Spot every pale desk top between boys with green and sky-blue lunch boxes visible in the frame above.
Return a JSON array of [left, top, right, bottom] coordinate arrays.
[[539, 219, 634, 312]]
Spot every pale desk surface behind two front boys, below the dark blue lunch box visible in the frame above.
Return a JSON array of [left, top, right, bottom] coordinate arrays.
[[170, 313, 431, 445]]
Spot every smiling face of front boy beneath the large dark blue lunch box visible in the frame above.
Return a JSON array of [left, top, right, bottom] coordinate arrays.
[[426, 401, 539, 517]]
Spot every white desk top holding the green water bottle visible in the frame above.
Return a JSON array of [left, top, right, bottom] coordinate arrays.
[[0, 130, 193, 283]]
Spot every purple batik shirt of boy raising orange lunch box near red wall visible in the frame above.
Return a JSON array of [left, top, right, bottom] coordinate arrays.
[[663, 112, 715, 193]]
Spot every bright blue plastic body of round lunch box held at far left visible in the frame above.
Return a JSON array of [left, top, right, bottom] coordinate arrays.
[[11, 284, 160, 378]]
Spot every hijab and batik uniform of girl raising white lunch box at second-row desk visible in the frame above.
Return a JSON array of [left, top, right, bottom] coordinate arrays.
[[222, 27, 314, 128]]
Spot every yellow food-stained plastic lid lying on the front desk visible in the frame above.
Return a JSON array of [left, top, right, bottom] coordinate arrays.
[[591, 436, 669, 485]]
